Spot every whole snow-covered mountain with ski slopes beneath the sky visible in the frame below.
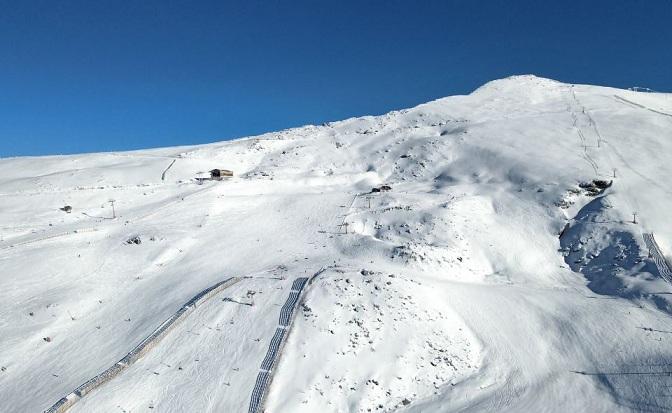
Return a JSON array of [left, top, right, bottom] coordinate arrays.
[[0, 76, 672, 413]]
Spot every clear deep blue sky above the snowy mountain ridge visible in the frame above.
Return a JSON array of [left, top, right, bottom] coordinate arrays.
[[0, 0, 672, 157]]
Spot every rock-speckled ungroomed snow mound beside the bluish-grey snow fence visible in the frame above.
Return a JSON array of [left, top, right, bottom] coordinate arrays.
[[266, 267, 479, 412]]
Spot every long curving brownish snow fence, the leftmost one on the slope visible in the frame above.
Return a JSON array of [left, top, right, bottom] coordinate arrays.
[[44, 277, 241, 413]]
